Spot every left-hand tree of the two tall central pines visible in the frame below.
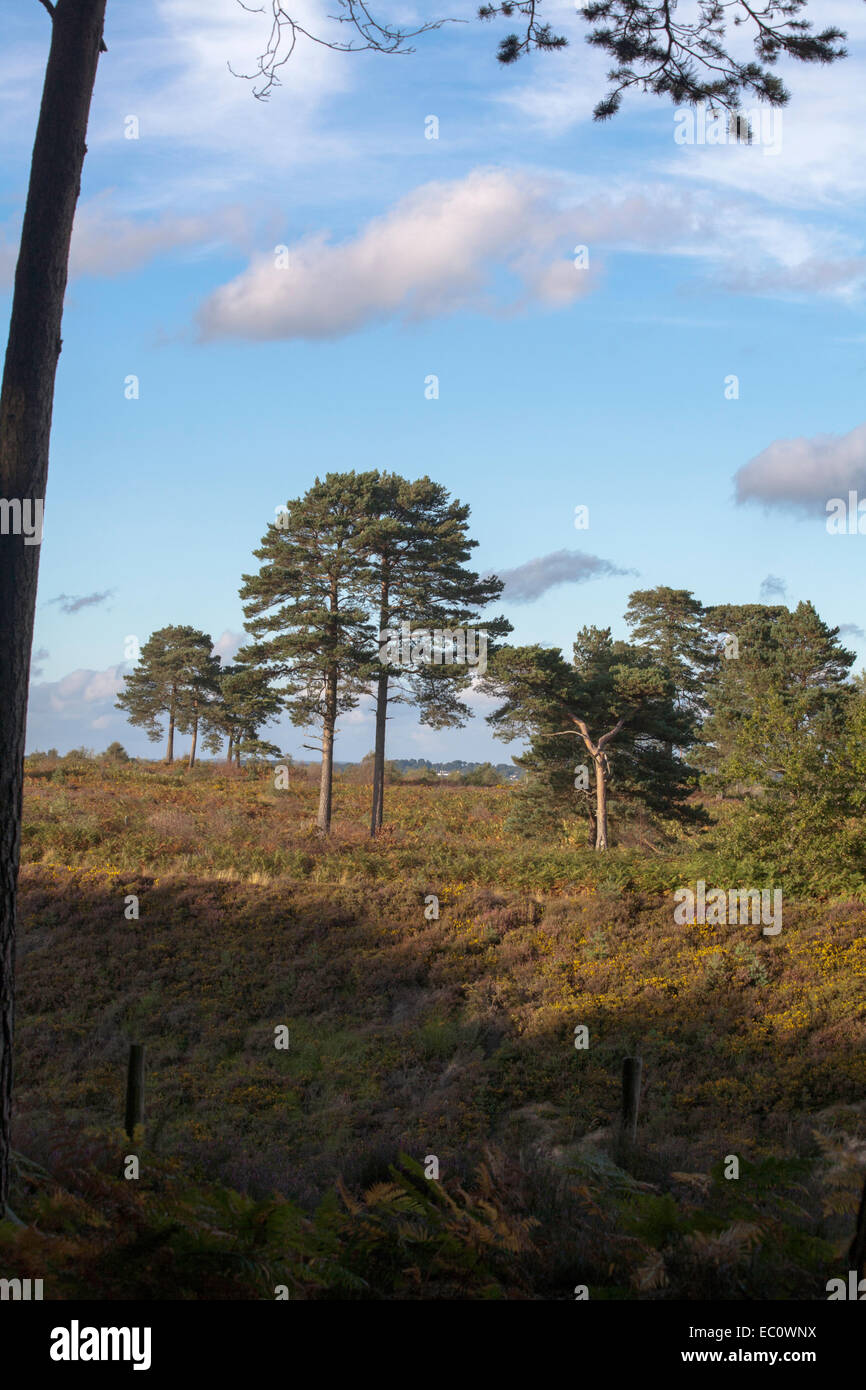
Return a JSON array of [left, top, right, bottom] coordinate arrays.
[[240, 473, 375, 834]]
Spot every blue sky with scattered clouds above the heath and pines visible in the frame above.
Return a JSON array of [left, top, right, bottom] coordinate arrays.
[[0, 0, 866, 760]]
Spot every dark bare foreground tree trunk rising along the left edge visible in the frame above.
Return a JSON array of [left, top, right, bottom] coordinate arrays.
[[0, 0, 106, 1216]]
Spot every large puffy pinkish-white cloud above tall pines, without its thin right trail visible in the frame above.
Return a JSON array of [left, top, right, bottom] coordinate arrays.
[[200, 170, 600, 339]]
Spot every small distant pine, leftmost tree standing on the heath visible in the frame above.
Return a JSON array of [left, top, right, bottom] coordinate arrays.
[[117, 627, 220, 763]]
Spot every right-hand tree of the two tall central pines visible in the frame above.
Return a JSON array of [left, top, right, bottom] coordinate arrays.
[[360, 473, 512, 835]]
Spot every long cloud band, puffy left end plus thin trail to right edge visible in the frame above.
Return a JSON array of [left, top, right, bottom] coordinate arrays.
[[199, 168, 866, 339]]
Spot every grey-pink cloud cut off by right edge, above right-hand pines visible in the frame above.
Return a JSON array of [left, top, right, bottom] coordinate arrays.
[[734, 424, 866, 516]]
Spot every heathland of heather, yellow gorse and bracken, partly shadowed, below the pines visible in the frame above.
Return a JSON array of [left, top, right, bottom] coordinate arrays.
[[0, 759, 866, 1300]]
